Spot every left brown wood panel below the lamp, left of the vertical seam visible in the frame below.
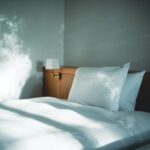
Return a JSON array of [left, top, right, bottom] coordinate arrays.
[[44, 71, 60, 98]]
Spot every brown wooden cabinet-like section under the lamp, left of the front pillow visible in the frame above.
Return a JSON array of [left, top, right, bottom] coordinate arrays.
[[43, 67, 76, 99]]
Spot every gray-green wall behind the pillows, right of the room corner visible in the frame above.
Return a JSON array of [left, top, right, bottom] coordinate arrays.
[[64, 0, 150, 70]]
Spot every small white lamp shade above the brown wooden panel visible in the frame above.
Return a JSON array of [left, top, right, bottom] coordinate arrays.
[[45, 58, 60, 69]]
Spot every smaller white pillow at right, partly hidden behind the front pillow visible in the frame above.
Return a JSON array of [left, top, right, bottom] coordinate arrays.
[[119, 71, 145, 111]]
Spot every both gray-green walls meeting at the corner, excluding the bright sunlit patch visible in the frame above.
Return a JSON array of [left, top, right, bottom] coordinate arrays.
[[0, 0, 150, 98]]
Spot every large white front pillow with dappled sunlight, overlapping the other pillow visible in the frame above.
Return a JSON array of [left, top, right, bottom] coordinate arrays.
[[68, 63, 130, 111]]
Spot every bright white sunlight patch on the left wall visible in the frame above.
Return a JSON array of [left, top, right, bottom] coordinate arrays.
[[0, 15, 32, 101]]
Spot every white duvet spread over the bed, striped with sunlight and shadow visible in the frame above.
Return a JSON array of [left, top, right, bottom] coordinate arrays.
[[0, 97, 150, 150]]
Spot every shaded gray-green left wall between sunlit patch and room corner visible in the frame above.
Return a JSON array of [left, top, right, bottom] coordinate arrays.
[[0, 0, 64, 98]]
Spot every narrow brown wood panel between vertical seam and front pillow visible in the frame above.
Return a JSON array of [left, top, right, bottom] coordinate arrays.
[[60, 73, 74, 99]]
